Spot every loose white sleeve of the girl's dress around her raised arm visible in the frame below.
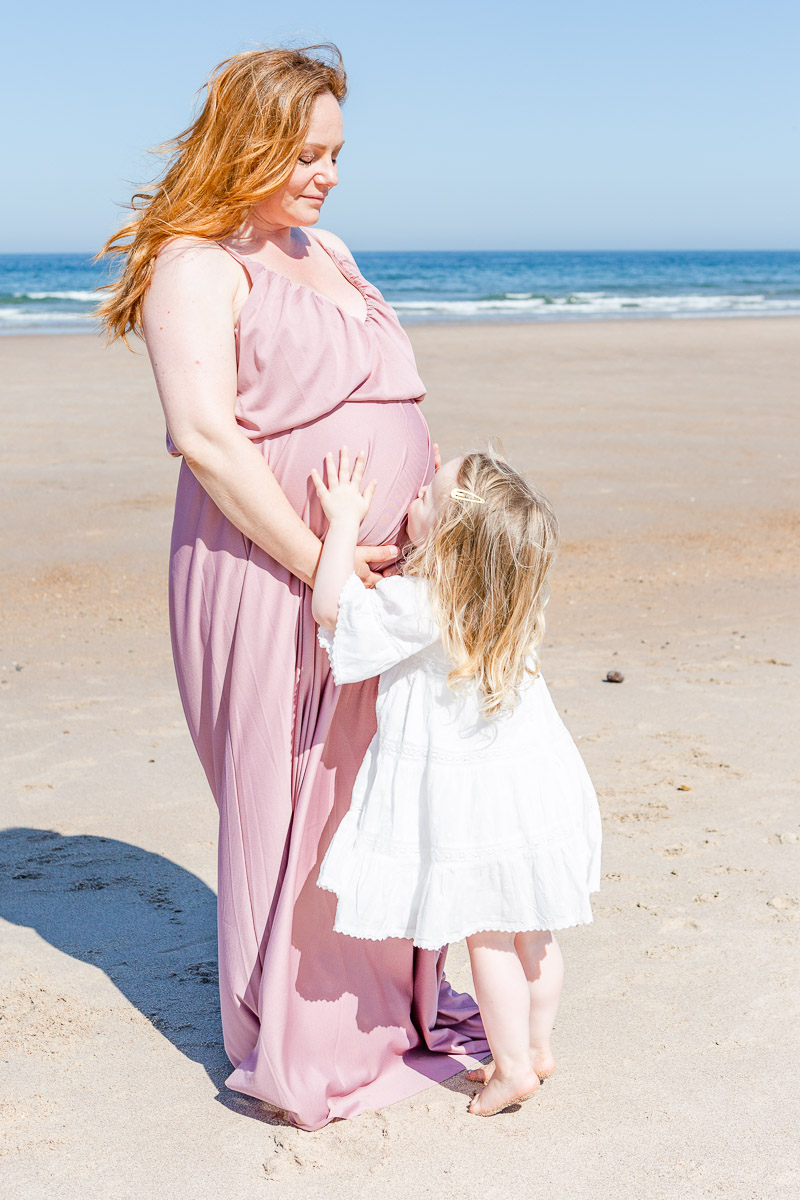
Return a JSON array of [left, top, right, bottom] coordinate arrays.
[[318, 575, 439, 684]]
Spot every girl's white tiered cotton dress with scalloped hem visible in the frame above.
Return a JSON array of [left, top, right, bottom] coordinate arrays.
[[318, 575, 601, 949]]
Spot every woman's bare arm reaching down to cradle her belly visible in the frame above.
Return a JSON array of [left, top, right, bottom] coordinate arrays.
[[144, 239, 393, 583]]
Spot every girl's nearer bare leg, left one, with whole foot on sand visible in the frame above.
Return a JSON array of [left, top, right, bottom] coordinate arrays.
[[467, 930, 539, 1116]]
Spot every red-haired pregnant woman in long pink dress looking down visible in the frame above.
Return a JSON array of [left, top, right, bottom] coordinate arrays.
[[101, 46, 486, 1129]]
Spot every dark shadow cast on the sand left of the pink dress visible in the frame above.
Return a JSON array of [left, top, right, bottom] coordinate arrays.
[[0, 829, 284, 1124]]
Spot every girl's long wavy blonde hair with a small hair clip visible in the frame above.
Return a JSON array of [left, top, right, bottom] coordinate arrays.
[[404, 452, 558, 718]]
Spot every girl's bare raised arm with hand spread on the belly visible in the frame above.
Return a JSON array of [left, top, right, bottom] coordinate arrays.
[[311, 446, 377, 629]]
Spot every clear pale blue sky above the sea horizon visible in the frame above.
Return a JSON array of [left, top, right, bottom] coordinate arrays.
[[0, 0, 800, 252]]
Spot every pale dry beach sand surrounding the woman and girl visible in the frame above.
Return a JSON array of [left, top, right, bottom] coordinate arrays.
[[0, 319, 800, 1200]]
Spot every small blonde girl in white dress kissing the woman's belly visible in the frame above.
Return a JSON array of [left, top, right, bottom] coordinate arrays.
[[312, 449, 600, 1116]]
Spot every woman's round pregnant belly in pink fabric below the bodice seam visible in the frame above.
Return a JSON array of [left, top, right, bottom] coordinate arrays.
[[261, 400, 433, 546]]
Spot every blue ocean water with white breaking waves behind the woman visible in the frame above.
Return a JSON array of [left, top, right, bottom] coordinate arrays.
[[0, 251, 800, 334]]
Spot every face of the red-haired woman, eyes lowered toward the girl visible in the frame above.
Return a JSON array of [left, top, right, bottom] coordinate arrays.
[[255, 91, 343, 229]]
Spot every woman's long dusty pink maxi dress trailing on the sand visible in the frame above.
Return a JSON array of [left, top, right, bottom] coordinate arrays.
[[170, 242, 487, 1129]]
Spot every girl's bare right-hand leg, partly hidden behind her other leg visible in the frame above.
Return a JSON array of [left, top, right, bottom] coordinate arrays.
[[467, 930, 564, 1084]]
